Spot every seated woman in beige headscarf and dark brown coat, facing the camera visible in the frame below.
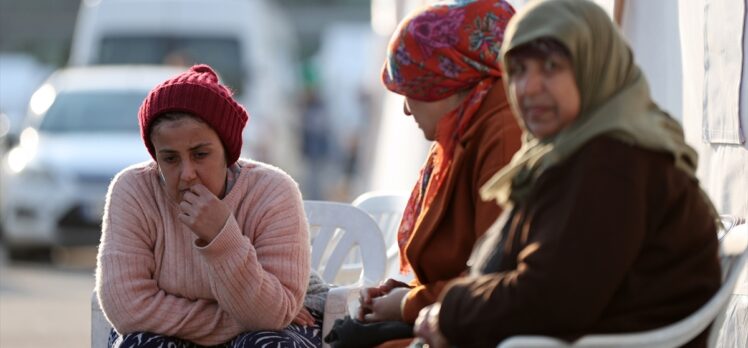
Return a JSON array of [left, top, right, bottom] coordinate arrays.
[[416, 0, 720, 347]]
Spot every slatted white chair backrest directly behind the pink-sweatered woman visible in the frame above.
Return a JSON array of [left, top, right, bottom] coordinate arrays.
[[304, 201, 386, 285]]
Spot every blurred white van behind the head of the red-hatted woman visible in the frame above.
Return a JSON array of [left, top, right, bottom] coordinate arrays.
[[69, 0, 301, 176]]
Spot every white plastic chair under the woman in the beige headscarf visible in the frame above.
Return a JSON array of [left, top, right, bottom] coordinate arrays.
[[498, 219, 748, 348]]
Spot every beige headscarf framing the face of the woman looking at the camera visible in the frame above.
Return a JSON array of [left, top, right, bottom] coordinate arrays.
[[480, 0, 716, 217]]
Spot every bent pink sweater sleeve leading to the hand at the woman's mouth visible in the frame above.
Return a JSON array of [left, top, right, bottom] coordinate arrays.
[[199, 174, 311, 330]]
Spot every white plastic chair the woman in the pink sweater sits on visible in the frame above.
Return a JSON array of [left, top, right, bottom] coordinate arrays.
[[91, 201, 386, 348]]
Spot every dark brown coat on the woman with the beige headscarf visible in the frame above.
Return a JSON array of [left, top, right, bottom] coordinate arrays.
[[439, 136, 720, 347]]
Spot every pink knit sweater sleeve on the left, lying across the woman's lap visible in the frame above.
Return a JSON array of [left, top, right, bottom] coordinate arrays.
[[96, 170, 242, 345]]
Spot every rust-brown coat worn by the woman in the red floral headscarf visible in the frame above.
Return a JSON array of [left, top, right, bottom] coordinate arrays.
[[403, 80, 521, 323]]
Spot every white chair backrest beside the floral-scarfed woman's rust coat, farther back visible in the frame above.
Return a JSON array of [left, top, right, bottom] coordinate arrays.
[[353, 191, 409, 280]]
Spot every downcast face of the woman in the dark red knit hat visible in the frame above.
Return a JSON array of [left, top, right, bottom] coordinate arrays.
[[151, 116, 227, 203]]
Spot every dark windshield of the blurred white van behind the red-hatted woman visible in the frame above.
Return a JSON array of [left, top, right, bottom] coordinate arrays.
[[98, 36, 244, 94]]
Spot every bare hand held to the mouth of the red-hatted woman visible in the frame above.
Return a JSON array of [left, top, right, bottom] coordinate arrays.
[[178, 184, 231, 244]]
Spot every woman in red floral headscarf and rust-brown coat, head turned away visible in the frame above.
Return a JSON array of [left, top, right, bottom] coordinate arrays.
[[359, 0, 521, 340]]
